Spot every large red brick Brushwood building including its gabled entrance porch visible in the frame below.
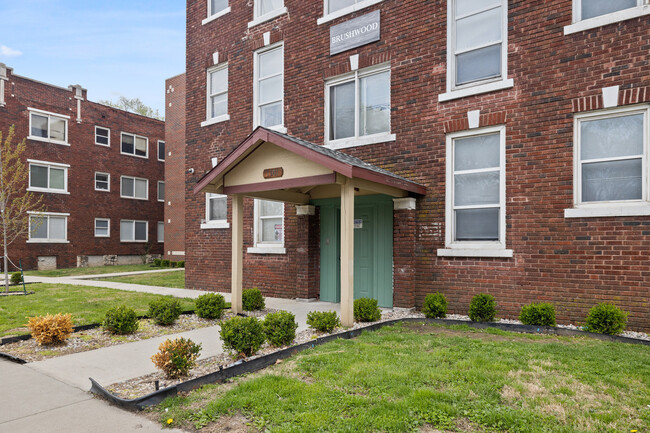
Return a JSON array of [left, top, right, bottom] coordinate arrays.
[[185, 0, 650, 330]]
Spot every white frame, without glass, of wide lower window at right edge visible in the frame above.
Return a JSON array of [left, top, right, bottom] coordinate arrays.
[[564, 104, 650, 218]]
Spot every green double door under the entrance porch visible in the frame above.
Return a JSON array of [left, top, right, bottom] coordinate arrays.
[[314, 195, 393, 308]]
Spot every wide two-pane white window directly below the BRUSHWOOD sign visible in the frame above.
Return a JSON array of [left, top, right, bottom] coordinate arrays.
[[325, 66, 395, 148]]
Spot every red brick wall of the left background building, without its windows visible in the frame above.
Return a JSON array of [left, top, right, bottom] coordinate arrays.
[[0, 66, 164, 269]]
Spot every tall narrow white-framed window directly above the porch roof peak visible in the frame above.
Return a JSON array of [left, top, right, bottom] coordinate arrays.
[[253, 44, 286, 132]]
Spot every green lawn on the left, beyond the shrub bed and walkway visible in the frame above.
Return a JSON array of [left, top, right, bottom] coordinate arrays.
[[0, 284, 194, 336]]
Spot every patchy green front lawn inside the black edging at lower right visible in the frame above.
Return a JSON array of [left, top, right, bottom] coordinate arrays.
[[152, 324, 650, 433]]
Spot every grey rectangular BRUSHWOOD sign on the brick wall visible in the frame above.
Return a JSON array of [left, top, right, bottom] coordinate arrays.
[[330, 11, 381, 56]]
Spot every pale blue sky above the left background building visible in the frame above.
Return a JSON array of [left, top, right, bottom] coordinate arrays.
[[0, 0, 185, 114]]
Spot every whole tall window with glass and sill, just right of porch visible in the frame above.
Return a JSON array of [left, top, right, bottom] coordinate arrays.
[[438, 126, 512, 257]]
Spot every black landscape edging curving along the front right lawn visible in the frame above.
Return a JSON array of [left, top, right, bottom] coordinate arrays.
[[89, 317, 650, 411]]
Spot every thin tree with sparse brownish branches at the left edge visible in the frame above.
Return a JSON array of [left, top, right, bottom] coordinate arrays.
[[0, 125, 43, 293]]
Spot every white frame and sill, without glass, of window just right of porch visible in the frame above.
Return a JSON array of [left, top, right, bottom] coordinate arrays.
[[437, 125, 513, 258]]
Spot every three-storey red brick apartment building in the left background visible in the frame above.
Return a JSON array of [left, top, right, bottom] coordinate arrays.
[[0, 64, 165, 269]]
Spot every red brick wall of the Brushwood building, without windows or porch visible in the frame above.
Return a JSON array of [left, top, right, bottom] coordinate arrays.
[[181, 0, 650, 329]]
